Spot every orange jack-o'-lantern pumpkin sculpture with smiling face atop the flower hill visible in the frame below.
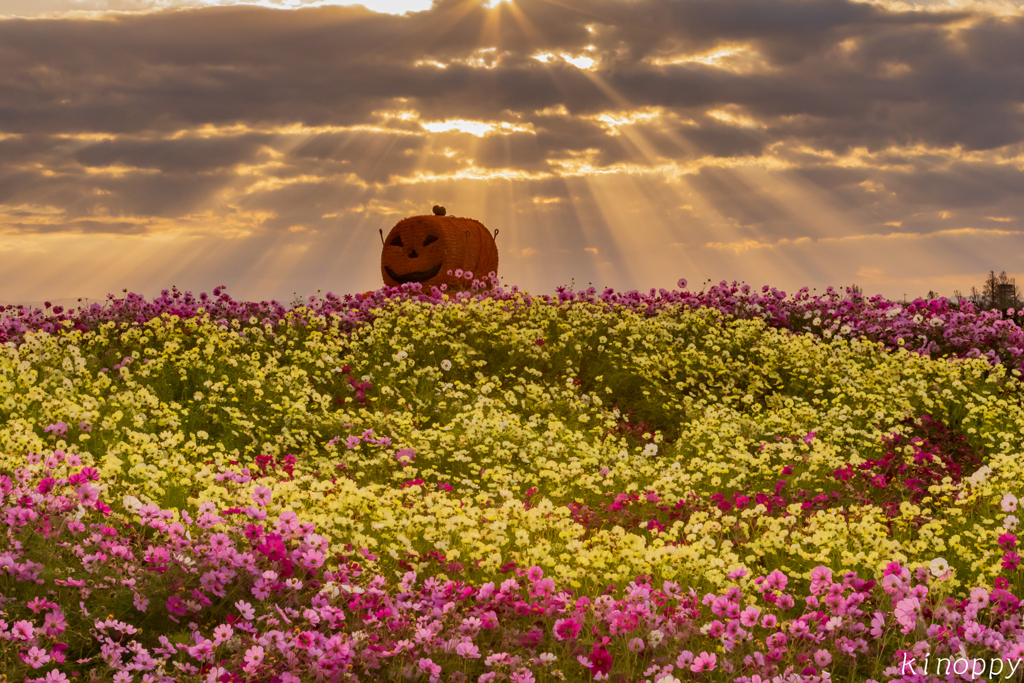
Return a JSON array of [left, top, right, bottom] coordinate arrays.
[[381, 206, 498, 291]]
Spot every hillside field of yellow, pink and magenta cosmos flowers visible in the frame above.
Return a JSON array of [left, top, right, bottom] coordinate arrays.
[[0, 275, 1024, 683]]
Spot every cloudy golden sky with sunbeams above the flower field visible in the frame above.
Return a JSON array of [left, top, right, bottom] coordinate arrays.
[[0, 0, 1024, 305]]
